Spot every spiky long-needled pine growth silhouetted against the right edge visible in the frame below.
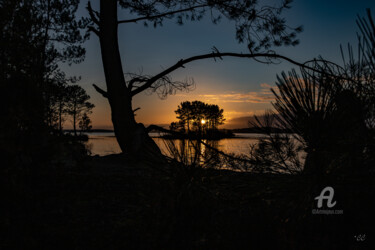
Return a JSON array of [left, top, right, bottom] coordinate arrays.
[[251, 10, 375, 174]]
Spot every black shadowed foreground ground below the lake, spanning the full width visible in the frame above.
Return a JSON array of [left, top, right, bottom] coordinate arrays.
[[0, 155, 375, 249]]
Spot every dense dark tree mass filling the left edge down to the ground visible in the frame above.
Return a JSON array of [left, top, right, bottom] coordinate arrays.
[[0, 0, 92, 166]]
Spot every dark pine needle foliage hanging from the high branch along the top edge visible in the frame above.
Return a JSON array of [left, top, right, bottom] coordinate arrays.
[[119, 0, 302, 52]]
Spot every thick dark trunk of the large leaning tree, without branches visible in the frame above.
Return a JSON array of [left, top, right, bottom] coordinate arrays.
[[99, 0, 161, 156]]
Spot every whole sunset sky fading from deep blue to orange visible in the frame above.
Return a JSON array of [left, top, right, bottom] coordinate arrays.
[[63, 0, 375, 128]]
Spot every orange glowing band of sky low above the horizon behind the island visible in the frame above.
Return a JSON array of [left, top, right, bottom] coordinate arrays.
[[87, 83, 272, 129]]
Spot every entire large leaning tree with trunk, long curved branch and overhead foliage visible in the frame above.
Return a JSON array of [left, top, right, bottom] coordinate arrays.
[[87, 0, 301, 155]]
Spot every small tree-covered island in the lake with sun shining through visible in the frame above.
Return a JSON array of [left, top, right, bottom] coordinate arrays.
[[163, 101, 234, 140]]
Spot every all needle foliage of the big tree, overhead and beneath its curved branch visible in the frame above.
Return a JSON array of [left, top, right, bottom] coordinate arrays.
[[108, 0, 302, 99]]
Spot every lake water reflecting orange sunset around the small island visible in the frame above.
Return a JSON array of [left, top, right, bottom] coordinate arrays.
[[87, 133, 264, 156]]
